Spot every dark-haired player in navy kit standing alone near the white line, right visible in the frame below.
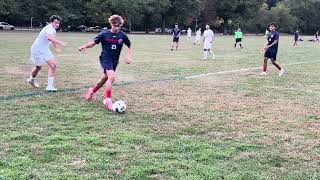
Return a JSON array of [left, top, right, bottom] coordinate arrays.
[[260, 23, 284, 76]]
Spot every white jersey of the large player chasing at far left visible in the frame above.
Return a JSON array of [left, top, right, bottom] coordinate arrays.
[[31, 24, 56, 52]]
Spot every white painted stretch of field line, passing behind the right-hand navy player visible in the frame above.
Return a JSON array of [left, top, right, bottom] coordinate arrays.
[[184, 60, 320, 79]]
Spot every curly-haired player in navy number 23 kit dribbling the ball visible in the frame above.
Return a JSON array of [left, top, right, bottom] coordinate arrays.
[[79, 15, 133, 110]]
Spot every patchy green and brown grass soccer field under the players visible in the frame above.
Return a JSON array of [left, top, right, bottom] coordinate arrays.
[[0, 32, 320, 180]]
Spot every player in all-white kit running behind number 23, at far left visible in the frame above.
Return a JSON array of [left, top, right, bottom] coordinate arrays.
[[27, 15, 66, 92]]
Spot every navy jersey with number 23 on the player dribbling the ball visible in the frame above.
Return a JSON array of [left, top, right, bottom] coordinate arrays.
[[94, 30, 131, 61]]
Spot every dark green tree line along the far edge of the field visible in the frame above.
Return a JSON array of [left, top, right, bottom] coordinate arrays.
[[0, 0, 320, 34]]
